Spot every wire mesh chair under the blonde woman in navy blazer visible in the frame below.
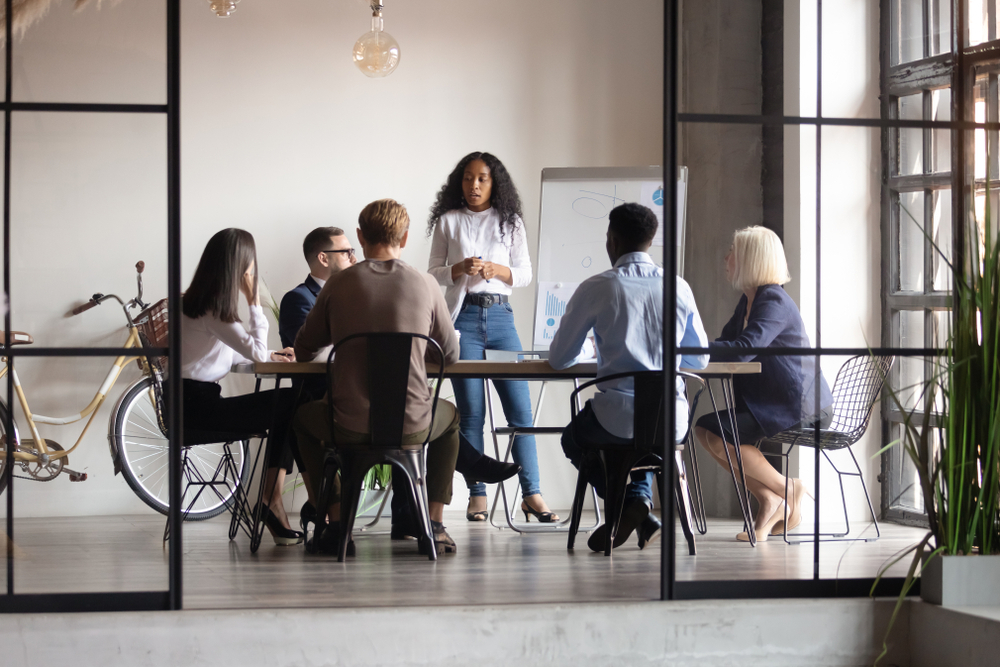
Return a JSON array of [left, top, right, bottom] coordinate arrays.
[[767, 355, 895, 544]]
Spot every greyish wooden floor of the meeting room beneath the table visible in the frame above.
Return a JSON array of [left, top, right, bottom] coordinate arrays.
[[0, 513, 923, 609]]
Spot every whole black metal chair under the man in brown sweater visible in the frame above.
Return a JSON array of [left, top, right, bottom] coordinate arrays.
[[318, 332, 445, 562]]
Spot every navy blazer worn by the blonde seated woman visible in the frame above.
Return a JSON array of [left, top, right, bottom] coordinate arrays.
[[709, 285, 833, 437]]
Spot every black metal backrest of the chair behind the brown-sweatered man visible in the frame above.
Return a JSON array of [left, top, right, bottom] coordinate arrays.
[[326, 331, 444, 448]]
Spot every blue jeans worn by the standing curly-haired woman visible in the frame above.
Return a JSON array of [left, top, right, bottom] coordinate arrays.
[[451, 303, 541, 496]]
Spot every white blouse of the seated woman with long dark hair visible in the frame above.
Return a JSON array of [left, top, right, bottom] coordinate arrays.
[[181, 306, 270, 382]]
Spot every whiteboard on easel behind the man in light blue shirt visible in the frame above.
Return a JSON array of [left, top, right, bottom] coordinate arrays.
[[532, 167, 688, 350]]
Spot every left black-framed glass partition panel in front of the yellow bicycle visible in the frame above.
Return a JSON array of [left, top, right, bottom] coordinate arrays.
[[0, 0, 181, 612]]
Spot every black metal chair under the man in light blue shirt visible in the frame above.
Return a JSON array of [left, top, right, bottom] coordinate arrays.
[[566, 371, 695, 556]]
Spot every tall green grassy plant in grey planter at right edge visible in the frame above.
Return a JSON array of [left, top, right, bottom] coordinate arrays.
[[873, 192, 1000, 664]]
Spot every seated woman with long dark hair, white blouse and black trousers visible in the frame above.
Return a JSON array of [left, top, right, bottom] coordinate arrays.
[[181, 228, 309, 546]]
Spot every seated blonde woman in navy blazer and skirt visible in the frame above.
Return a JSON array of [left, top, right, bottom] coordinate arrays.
[[695, 227, 833, 542]]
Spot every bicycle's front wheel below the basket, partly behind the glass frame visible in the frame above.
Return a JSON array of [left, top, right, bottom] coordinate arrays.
[[110, 377, 250, 521]]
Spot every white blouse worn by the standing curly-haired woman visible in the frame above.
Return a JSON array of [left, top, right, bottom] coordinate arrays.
[[427, 207, 531, 322]]
